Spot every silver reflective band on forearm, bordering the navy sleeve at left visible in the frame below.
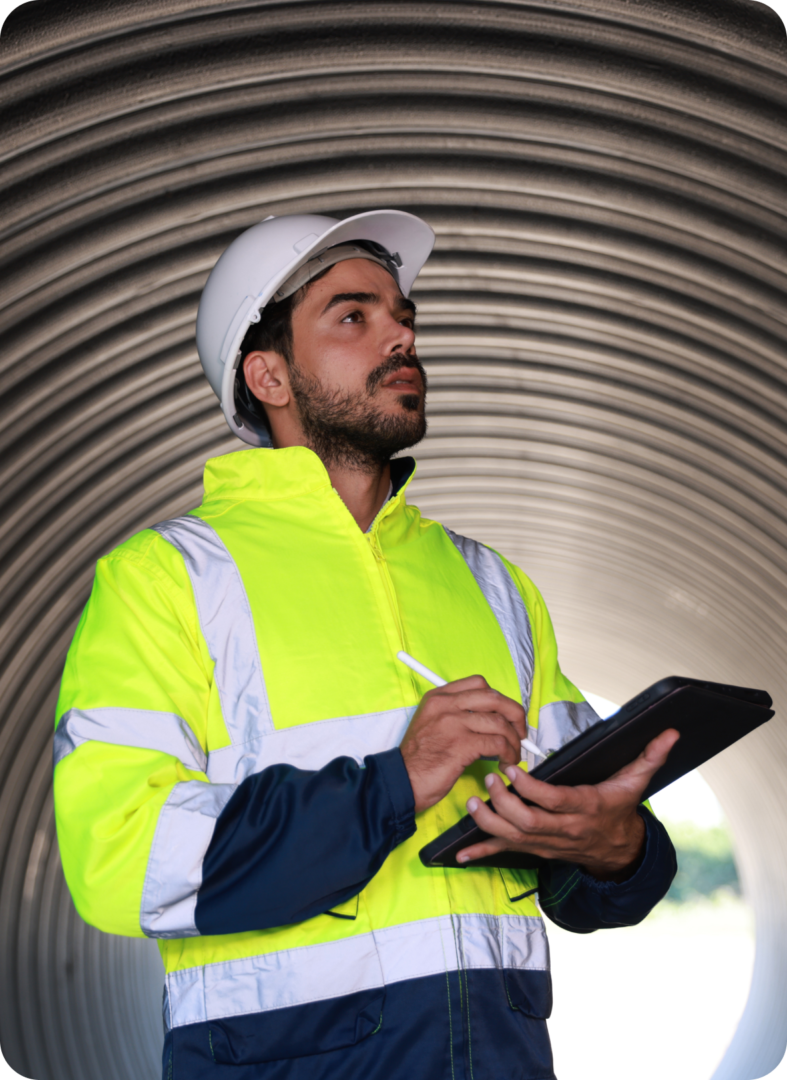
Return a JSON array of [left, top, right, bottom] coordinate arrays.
[[139, 780, 235, 937]]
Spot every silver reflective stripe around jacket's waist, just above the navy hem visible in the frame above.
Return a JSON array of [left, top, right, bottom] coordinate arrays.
[[164, 915, 549, 1027]]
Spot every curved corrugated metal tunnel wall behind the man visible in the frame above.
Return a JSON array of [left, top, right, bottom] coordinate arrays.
[[0, 0, 787, 1080]]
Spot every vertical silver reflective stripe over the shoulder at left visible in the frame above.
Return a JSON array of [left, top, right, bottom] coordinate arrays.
[[153, 515, 273, 746]]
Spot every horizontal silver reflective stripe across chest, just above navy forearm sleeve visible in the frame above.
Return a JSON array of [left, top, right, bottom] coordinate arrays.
[[207, 705, 418, 784]]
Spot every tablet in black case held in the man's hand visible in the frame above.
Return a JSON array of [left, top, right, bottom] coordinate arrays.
[[420, 675, 773, 869]]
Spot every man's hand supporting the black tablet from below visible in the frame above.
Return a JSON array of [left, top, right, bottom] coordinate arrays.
[[458, 728, 680, 881]]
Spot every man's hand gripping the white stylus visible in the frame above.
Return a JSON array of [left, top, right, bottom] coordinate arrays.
[[401, 675, 526, 813]]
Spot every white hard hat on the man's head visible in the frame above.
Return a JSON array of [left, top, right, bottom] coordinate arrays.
[[196, 210, 434, 446]]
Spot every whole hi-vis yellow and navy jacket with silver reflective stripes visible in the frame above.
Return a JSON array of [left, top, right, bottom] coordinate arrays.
[[55, 447, 674, 1080]]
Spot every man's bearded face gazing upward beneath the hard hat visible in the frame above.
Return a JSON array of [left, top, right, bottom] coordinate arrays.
[[289, 259, 426, 468]]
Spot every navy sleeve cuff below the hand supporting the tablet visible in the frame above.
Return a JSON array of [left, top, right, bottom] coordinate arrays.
[[539, 807, 678, 934]]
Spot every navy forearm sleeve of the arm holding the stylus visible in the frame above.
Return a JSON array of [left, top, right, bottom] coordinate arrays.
[[195, 748, 416, 934]]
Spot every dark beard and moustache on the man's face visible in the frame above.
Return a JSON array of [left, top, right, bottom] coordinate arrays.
[[289, 353, 426, 472]]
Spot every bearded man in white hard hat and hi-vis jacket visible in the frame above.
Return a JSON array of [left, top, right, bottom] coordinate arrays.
[[55, 211, 677, 1080]]
